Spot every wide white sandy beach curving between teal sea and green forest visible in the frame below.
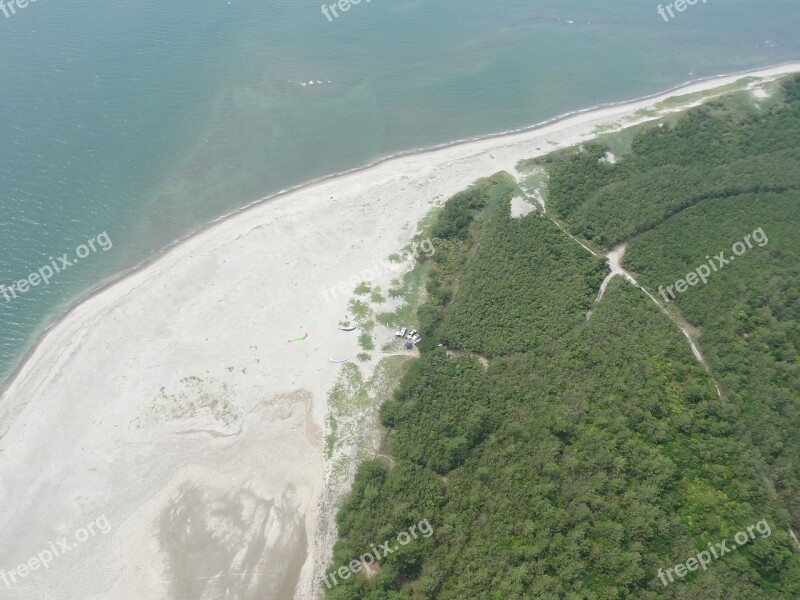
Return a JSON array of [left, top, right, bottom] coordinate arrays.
[[0, 64, 800, 600]]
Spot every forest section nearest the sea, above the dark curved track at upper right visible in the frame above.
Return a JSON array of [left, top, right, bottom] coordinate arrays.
[[539, 78, 800, 248]]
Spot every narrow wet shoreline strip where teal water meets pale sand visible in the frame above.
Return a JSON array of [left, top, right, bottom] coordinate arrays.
[[0, 61, 800, 404]]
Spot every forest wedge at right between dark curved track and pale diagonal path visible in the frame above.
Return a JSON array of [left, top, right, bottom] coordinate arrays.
[[625, 191, 800, 548]]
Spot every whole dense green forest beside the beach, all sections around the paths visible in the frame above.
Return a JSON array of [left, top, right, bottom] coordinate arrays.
[[327, 78, 800, 600]]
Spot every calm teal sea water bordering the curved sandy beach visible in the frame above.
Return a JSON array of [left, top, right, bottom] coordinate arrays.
[[0, 0, 800, 379]]
